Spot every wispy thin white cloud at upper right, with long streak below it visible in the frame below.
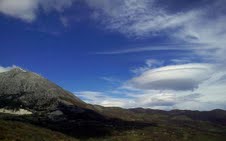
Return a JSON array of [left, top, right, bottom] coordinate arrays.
[[86, 0, 226, 64]]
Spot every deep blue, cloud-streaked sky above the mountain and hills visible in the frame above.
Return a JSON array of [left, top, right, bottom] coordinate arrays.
[[0, 0, 226, 110]]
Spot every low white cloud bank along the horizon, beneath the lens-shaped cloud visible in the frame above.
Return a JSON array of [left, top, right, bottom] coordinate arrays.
[[75, 90, 203, 110]]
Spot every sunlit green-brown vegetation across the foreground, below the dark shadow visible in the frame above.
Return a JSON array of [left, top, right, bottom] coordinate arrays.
[[0, 111, 226, 141]]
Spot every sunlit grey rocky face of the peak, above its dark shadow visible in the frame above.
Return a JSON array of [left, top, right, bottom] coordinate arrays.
[[0, 68, 86, 112]]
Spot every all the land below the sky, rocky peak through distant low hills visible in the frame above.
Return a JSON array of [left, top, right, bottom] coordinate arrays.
[[0, 68, 226, 141]]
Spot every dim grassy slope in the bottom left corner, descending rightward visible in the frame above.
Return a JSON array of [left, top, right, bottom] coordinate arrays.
[[0, 120, 78, 141]]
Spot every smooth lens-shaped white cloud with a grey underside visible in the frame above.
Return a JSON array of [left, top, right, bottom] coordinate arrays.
[[126, 64, 213, 90]]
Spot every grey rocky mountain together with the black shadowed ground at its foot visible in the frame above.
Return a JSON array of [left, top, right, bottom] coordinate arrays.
[[0, 68, 150, 137]]
